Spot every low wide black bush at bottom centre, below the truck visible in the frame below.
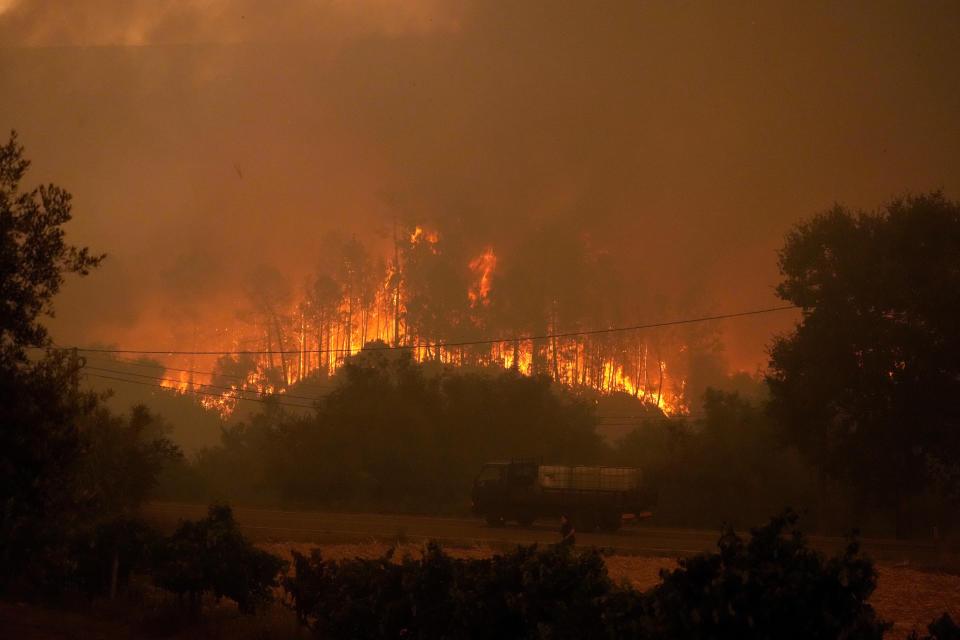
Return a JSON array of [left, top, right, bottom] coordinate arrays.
[[283, 542, 614, 638]]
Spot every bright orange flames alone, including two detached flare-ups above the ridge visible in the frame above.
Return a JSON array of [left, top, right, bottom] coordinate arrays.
[[146, 226, 688, 417]]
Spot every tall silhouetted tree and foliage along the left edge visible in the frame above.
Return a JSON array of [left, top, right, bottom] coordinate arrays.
[[0, 135, 177, 596]]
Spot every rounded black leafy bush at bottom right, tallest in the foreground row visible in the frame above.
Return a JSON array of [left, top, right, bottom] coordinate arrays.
[[644, 511, 890, 639]]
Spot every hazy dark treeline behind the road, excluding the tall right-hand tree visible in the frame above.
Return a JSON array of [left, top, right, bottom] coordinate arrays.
[[160, 351, 952, 536]]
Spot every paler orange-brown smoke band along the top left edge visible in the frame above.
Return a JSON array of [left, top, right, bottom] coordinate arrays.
[[0, 0, 460, 48]]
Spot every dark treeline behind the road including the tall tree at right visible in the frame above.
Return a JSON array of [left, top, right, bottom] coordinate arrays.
[[154, 193, 960, 537]]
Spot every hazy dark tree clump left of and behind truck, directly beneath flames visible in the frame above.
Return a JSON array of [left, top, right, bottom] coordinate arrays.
[[176, 351, 604, 510]]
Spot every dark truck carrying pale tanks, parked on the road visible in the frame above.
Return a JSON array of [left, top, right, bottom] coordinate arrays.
[[471, 459, 657, 531]]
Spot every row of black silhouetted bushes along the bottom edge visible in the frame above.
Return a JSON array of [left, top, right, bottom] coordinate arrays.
[[8, 506, 960, 640]]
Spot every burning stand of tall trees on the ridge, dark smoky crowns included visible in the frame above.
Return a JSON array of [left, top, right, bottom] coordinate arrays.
[[163, 225, 711, 412]]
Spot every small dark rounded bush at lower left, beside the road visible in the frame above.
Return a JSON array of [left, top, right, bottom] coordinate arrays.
[[154, 505, 286, 613]]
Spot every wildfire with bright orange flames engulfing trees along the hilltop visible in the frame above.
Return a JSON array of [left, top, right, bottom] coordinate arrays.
[[152, 226, 686, 415]]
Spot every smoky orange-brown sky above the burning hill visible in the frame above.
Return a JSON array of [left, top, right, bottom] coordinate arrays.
[[0, 0, 960, 370]]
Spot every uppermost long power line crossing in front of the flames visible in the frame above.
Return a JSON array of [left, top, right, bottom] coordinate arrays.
[[69, 305, 801, 356]]
